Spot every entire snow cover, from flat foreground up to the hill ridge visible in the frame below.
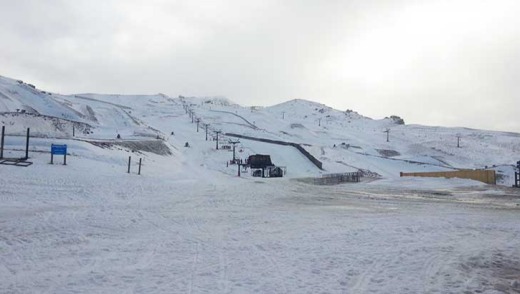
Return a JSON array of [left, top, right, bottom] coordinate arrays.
[[0, 77, 520, 293]]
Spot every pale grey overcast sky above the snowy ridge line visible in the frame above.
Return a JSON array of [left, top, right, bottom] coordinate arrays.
[[0, 0, 520, 132]]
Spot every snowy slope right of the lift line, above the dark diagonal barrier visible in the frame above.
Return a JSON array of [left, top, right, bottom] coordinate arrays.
[[176, 99, 520, 183]]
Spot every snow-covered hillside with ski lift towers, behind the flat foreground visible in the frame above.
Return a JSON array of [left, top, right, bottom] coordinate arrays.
[[0, 73, 520, 185]]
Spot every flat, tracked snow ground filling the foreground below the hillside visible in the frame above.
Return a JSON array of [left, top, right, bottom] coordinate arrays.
[[0, 160, 520, 293]]
